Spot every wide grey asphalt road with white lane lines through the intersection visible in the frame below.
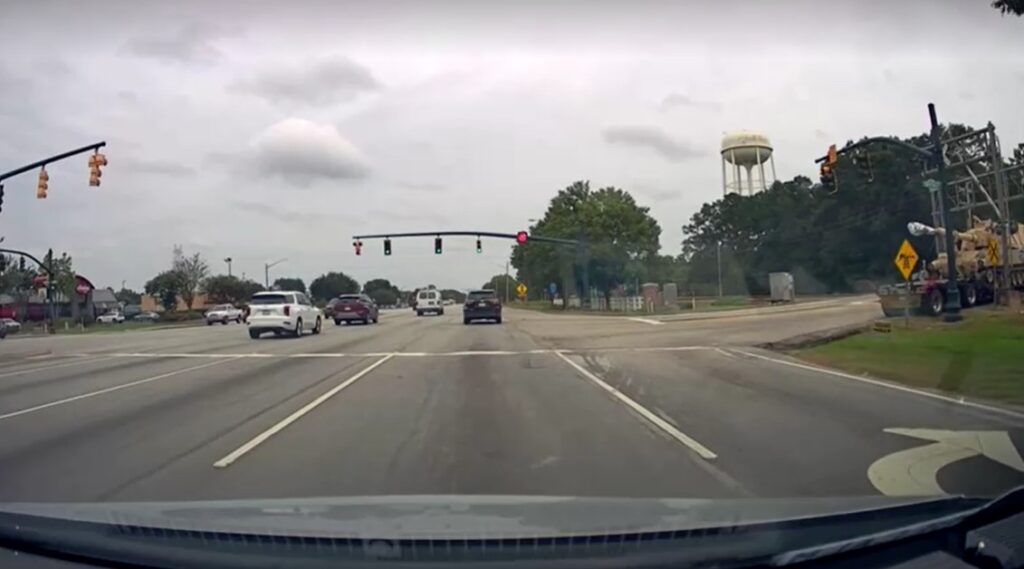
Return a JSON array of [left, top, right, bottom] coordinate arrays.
[[0, 300, 1024, 501]]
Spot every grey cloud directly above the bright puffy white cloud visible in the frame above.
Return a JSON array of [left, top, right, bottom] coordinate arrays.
[[229, 56, 380, 105]]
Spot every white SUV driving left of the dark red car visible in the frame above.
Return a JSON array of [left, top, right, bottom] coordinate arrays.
[[248, 291, 324, 340]]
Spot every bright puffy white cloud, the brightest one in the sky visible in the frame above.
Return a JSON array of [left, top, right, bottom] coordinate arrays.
[[248, 119, 370, 185]]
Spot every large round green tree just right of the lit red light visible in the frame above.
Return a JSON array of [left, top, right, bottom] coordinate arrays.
[[512, 181, 662, 302]]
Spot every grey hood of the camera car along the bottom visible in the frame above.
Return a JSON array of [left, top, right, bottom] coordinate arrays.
[[0, 495, 977, 539]]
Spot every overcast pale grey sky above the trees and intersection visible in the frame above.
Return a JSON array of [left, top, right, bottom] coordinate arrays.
[[0, 0, 1024, 290]]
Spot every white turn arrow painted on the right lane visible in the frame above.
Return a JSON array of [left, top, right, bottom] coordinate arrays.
[[867, 429, 1024, 496]]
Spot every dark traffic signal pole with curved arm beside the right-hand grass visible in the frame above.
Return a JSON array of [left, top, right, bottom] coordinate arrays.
[[814, 102, 958, 322]]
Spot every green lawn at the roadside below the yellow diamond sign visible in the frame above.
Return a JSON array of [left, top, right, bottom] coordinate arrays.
[[794, 310, 1024, 404]]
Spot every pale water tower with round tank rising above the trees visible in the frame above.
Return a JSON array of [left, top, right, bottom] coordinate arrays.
[[722, 130, 775, 195]]
